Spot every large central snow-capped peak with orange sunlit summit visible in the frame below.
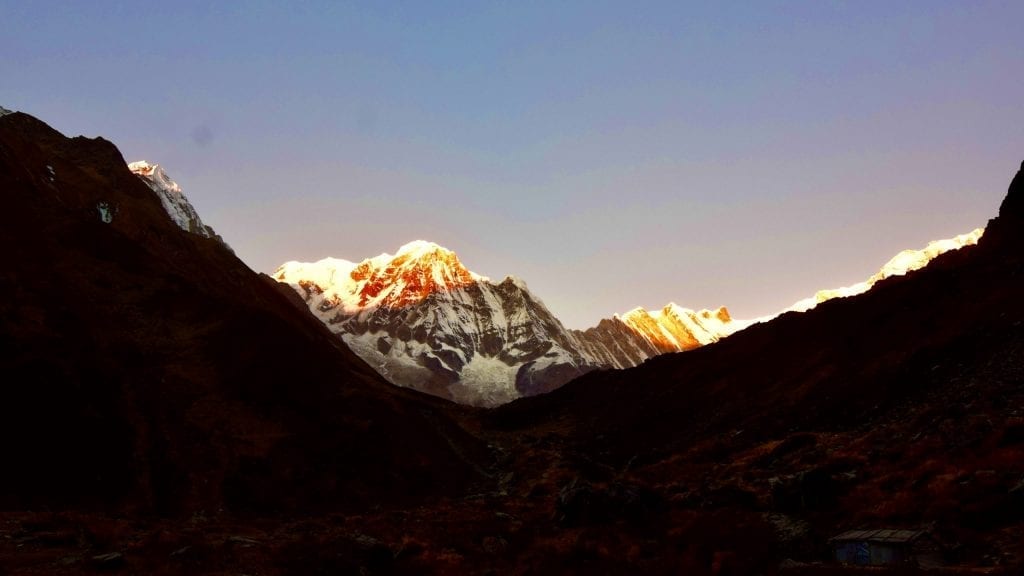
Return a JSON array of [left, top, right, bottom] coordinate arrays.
[[272, 241, 596, 406]]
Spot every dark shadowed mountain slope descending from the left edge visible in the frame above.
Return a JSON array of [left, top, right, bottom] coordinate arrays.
[[0, 113, 487, 515]]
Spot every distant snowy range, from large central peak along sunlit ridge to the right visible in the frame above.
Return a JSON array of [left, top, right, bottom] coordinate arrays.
[[272, 229, 983, 407]]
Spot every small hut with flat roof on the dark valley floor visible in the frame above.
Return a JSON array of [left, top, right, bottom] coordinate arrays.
[[828, 529, 942, 568]]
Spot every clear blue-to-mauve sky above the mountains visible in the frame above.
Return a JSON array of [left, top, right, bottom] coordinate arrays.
[[0, 0, 1024, 328]]
